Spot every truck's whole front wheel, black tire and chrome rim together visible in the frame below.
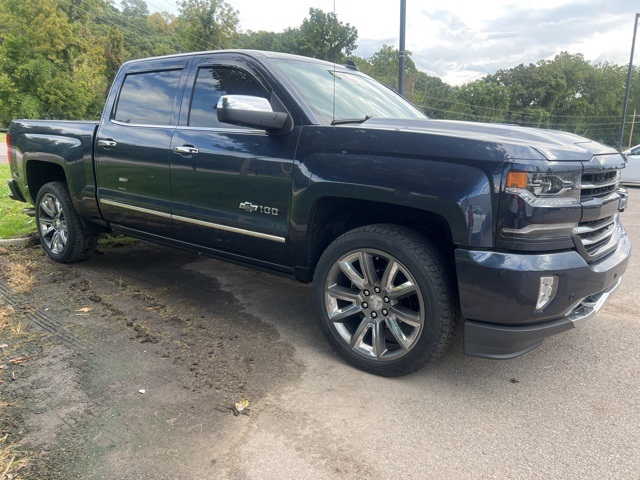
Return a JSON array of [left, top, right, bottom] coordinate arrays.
[[313, 224, 459, 377]]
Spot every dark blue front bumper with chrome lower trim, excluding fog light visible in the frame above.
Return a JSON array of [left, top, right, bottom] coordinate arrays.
[[456, 227, 631, 358]]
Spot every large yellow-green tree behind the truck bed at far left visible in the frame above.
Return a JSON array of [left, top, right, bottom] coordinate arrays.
[[0, 0, 106, 125]]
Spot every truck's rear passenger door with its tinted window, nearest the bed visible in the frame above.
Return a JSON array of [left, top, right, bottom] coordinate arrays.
[[95, 57, 189, 237]]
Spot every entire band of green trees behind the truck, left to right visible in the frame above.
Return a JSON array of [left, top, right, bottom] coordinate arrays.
[[0, 0, 640, 145]]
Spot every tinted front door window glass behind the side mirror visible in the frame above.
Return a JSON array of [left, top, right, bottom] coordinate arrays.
[[189, 67, 269, 128]]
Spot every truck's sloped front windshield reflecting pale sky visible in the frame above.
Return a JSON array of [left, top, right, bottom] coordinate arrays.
[[277, 60, 427, 124]]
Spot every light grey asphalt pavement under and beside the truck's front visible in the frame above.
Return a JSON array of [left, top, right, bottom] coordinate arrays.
[[181, 188, 640, 480]]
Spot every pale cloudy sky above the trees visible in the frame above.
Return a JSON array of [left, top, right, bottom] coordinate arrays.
[[148, 0, 640, 85]]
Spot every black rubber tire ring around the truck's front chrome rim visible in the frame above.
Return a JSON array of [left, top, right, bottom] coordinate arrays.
[[313, 225, 456, 376]]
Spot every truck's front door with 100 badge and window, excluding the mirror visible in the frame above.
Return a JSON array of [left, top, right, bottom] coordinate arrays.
[[171, 53, 297, 268]]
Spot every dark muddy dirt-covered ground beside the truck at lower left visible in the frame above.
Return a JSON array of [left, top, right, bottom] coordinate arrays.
[[0, 242, 301, 479]]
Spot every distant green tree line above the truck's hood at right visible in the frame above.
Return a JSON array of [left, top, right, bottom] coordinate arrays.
[[458, 52, 640, 145]]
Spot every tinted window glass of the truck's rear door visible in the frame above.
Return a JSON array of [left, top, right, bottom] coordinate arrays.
[[114, 70, 182, 125]]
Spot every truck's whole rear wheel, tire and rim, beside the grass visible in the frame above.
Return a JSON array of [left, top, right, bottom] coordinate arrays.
[[36, 182, 98, 263]]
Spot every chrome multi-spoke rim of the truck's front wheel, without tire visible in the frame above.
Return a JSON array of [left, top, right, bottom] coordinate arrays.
[[325, 249, 425, 361]]
